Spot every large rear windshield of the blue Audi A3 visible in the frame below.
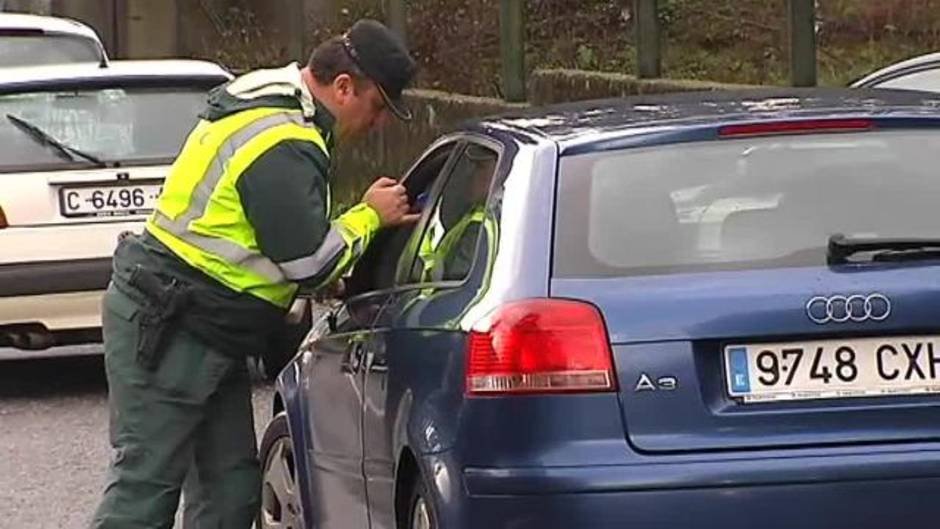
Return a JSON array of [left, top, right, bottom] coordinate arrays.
[[554, 130, 940, 277]]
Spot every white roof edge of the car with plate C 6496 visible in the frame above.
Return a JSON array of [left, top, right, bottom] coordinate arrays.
[[0, 59, 232, 92]]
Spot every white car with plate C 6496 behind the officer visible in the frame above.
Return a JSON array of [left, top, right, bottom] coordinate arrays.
[[0, 60, 231, 349]]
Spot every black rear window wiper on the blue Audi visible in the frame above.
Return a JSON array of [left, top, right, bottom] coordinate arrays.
[[826, 233, 940, 265]]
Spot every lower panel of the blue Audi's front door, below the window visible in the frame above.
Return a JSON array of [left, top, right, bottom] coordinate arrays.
[[302, 294, 387, 529]]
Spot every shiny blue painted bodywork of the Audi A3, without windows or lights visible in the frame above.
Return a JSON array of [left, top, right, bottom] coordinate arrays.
[[266, 88, 940, 529]]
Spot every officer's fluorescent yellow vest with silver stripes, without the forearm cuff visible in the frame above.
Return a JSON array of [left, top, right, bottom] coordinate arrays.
[[147, 108, 327, 307]]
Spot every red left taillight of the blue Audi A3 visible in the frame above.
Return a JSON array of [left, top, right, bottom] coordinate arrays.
[[466, 299, 616, 396]]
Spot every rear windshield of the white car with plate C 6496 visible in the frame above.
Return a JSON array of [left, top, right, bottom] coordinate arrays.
[[0, 87, 208, 172]]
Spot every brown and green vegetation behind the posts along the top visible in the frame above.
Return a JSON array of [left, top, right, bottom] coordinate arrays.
[[198, 0, 940, 96]]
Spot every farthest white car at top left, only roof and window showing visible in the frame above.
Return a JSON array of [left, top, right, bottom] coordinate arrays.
[[0, 13, 108, 67]]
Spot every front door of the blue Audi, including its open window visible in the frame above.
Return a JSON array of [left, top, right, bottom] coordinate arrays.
[[302, 140, 455, 529]]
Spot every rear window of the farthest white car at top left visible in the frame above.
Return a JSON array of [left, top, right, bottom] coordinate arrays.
[[0, 34, 102, 66]]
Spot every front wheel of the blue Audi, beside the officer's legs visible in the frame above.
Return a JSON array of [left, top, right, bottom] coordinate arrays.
[[256, 412, 304, 529]]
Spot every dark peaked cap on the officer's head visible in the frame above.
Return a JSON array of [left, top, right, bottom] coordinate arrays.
[[343, 19, 417, 121]]
